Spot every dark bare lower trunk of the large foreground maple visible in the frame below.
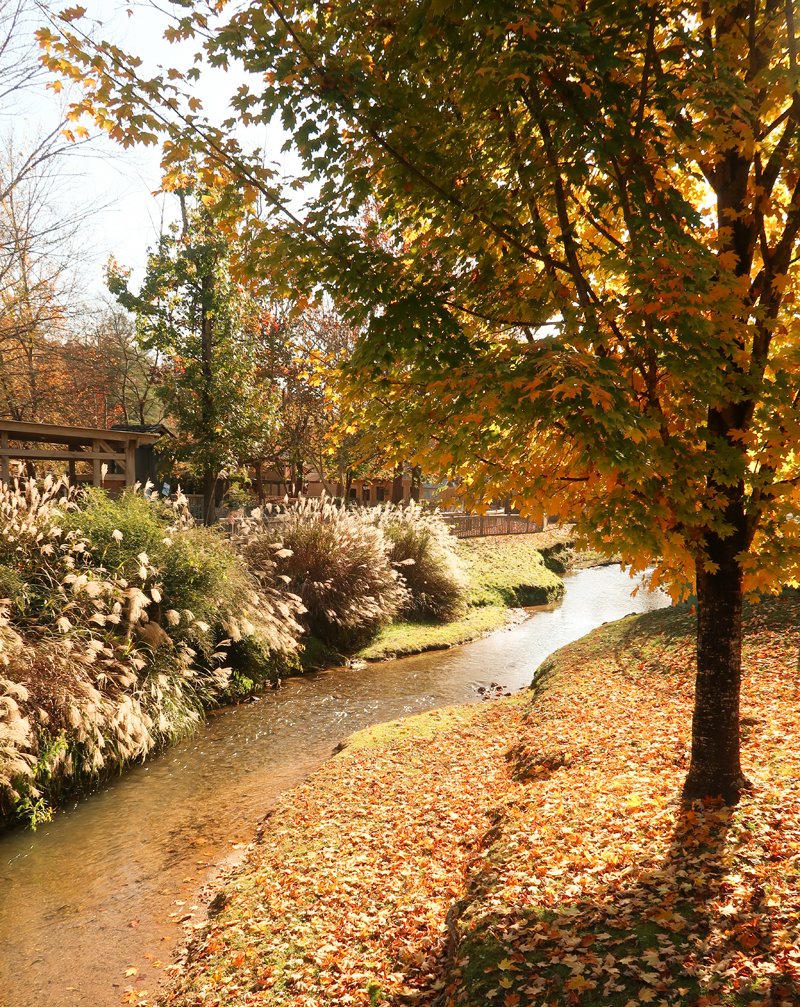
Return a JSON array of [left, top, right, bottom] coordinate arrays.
[[683, 534, 750, 805]]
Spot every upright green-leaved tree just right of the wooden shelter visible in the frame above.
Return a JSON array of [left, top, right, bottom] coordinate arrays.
[[108, 195, 276, 523]]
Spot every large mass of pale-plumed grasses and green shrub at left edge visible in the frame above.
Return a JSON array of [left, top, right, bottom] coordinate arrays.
[[0, 480, 301, 822]]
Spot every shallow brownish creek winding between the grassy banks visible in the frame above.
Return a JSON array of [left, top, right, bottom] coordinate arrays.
[[0, 567, 668, 1007]]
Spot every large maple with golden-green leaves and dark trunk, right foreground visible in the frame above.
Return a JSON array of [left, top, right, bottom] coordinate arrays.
[[40, 0, 800, 801]]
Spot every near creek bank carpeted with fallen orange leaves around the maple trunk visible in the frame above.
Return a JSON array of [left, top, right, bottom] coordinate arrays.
[[153, 594, 800, 1007]]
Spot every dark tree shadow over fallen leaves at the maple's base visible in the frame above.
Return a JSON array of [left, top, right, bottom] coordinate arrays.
[[447, 802, 789, 1007]]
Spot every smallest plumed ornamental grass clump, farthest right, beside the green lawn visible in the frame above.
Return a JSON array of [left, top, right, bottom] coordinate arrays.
[[368, 500, 468, 620]]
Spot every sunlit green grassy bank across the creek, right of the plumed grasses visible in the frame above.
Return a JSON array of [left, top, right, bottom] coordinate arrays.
[[356, 530, 569, 661]]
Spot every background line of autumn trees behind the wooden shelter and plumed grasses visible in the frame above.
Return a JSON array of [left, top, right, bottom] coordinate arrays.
[[0, 0, 398, 522]]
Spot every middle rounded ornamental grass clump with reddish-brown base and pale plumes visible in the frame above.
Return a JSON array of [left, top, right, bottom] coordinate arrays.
[[238, 498, 408, 648]]
